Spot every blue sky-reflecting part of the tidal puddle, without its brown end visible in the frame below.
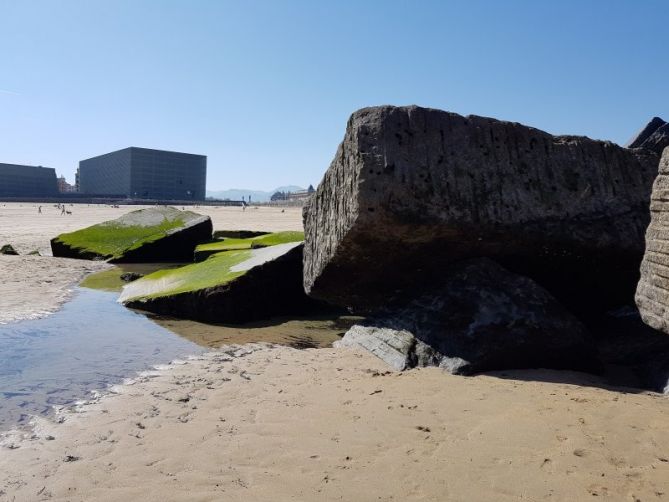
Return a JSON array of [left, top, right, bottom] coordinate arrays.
[[0, 288, 203, 430]]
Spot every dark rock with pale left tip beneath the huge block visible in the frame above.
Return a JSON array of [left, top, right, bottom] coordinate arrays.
[[337, 258, 597, 374]]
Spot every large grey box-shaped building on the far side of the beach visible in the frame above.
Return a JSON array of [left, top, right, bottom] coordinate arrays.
[[78, 146, 207, 200]]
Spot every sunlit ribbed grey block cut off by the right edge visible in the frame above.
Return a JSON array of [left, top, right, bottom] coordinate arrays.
[[636, 148, 669, 333]]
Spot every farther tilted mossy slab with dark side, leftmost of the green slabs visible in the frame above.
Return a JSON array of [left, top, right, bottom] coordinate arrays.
[[51, 206, 212, 263]]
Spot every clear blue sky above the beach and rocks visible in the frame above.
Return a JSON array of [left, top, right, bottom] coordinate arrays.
[[0, 0, 669, 190]]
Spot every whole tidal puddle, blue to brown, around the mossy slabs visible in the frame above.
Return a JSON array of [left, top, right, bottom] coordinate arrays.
[[0, 263, 360, 431]]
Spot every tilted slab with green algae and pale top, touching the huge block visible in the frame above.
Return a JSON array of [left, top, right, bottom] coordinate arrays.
[[119, 242, 328, 323]]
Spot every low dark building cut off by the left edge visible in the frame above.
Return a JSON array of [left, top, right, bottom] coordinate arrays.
[[0, 164, 58, 197]]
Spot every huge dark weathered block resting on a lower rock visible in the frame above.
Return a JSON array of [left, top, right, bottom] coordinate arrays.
[[304, 106, 659, 312]]
